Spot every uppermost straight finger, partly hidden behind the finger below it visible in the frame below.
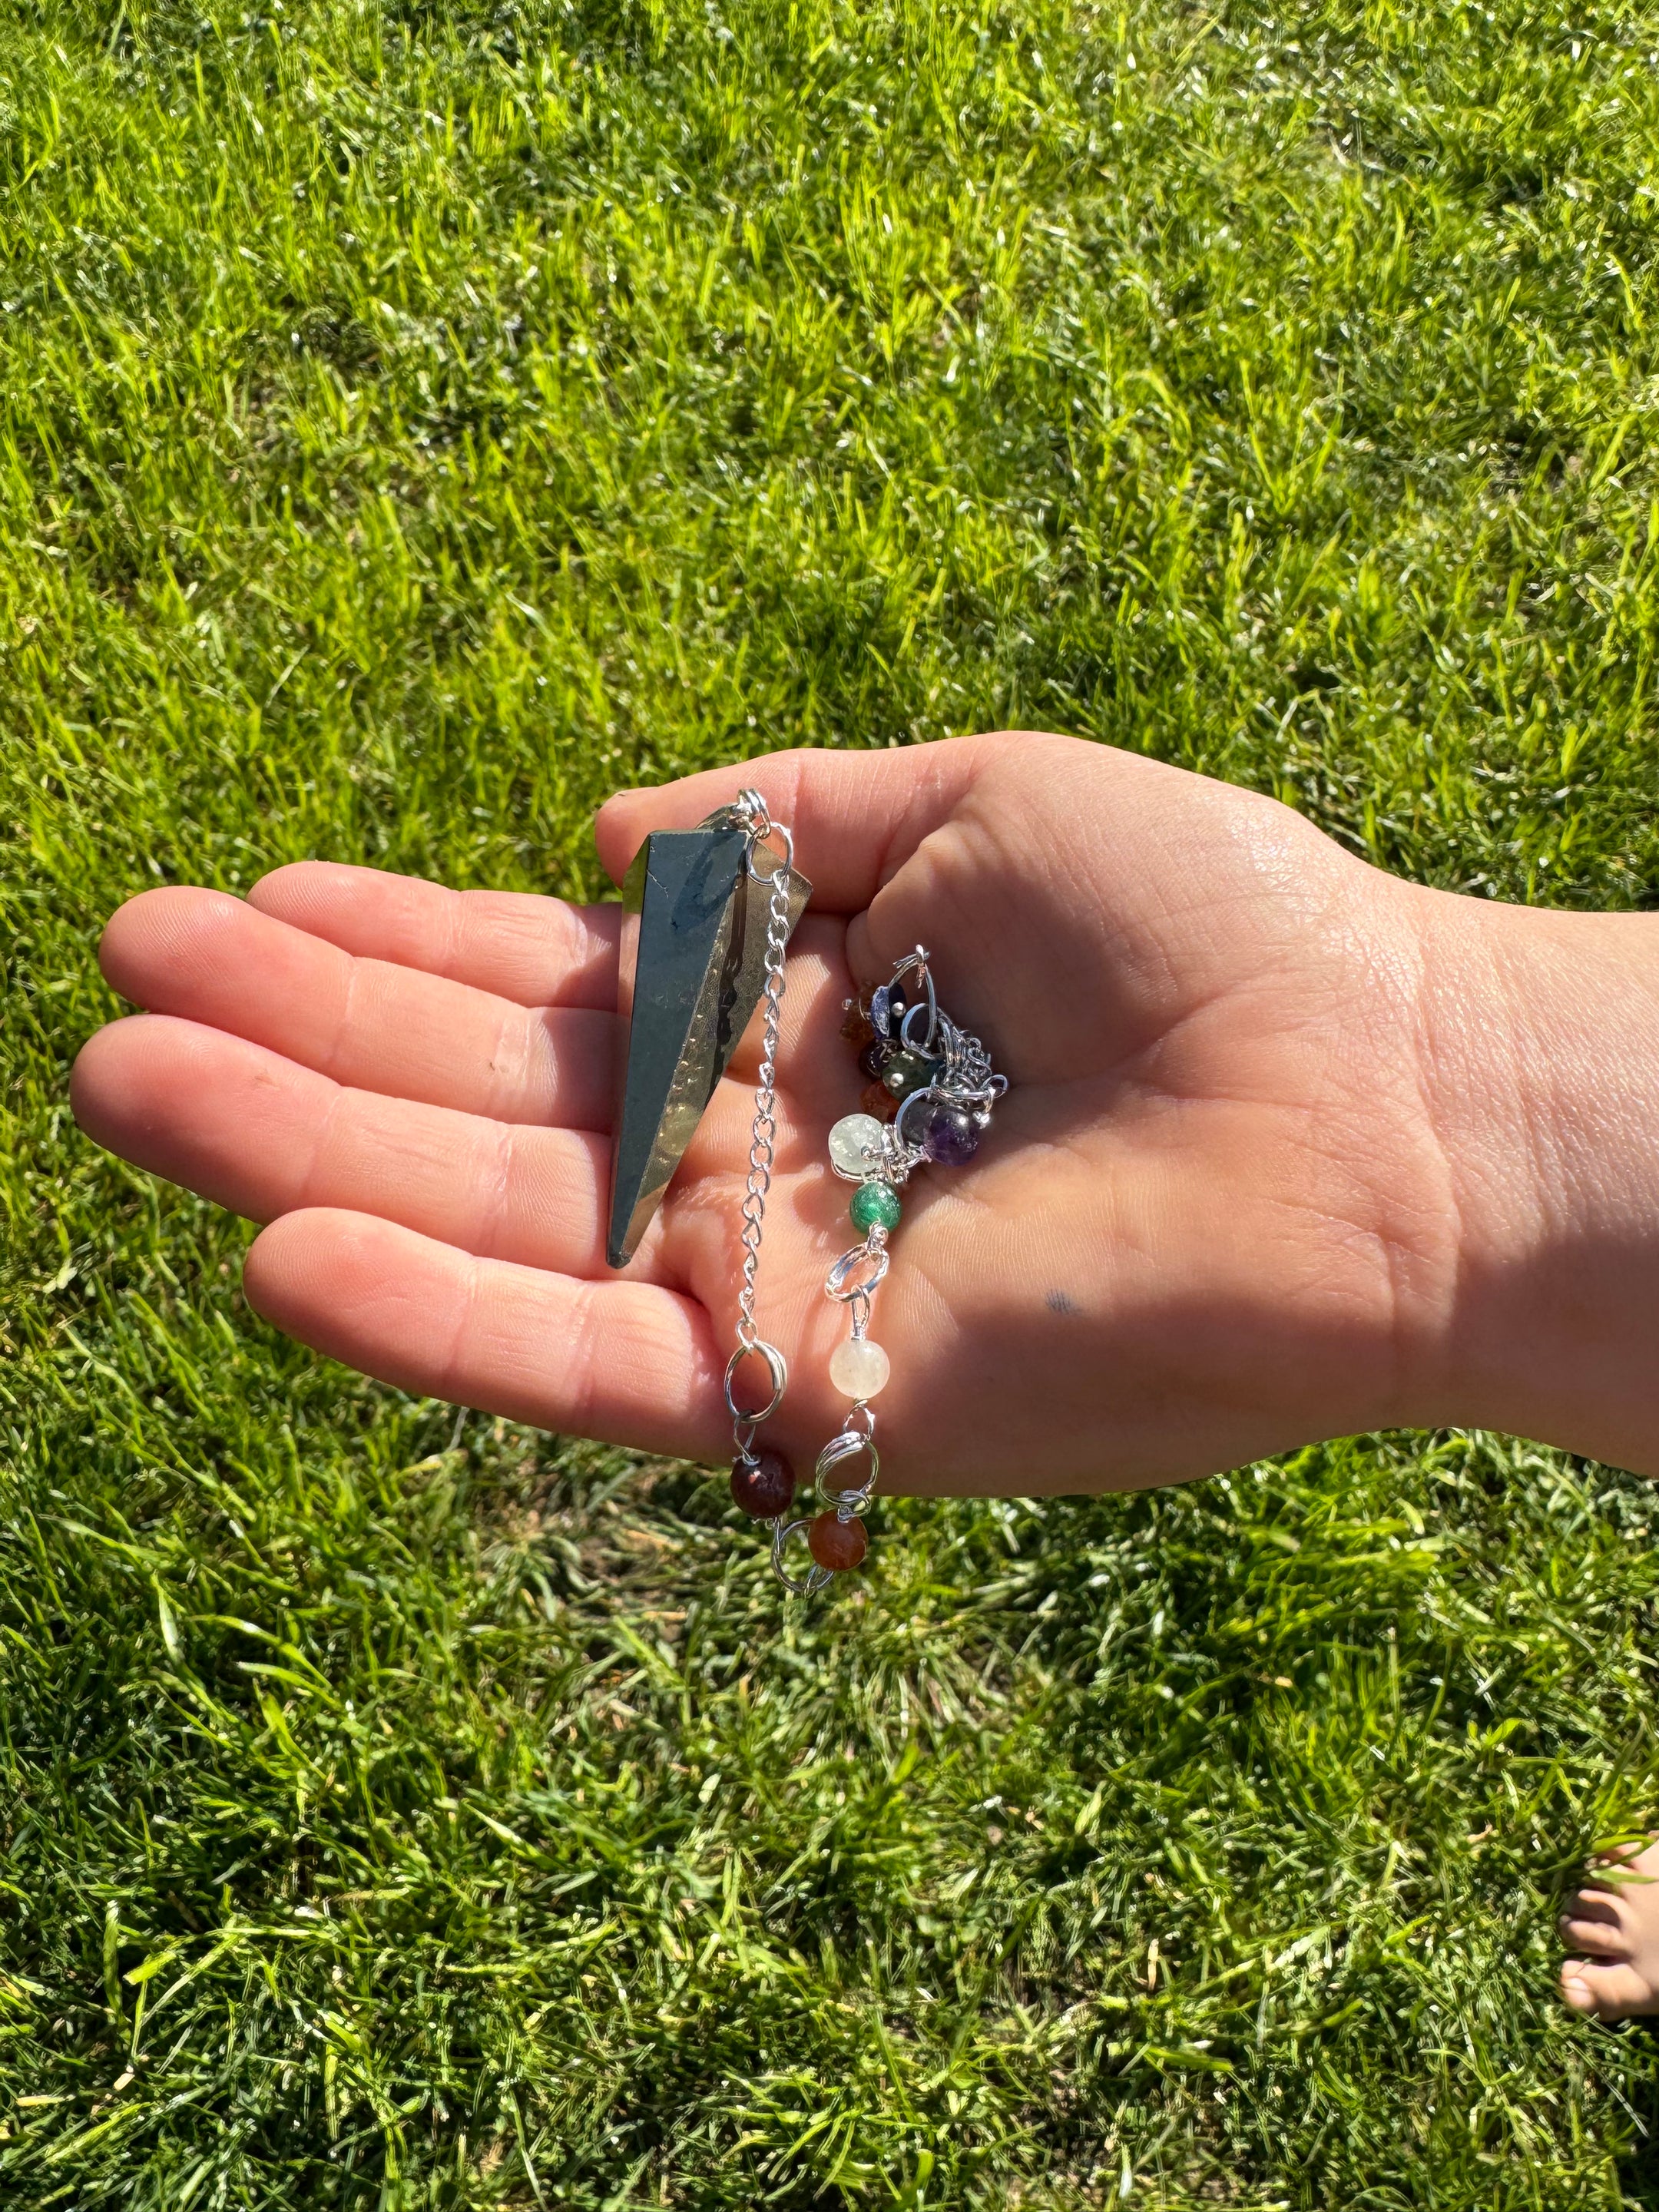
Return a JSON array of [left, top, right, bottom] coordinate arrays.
[[248, 860, 621, 1013]]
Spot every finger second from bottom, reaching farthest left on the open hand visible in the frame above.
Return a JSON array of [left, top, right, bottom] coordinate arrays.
[[71, 1013, 681, 1281]]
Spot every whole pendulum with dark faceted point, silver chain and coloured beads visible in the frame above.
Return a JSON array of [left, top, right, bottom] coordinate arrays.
[[606, 792, 1008, 1594]]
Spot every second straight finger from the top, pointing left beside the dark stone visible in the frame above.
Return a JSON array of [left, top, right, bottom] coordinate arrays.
[[100, 887, 618, 1131]]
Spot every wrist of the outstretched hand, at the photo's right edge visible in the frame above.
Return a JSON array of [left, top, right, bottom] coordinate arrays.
[[1411, 892, 1659, 1473]]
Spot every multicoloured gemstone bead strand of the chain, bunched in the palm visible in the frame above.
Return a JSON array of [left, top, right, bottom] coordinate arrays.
[[770, 945, 1008, 1594]]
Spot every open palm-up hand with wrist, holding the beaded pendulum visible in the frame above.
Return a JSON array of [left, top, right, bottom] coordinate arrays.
[[75, 732, 1659, 1493]]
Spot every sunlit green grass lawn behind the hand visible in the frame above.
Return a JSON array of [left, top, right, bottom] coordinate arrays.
[[0, 0, 1659, 2212]]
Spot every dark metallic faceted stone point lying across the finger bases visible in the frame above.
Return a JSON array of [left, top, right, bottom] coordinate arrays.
[[606, 816, 812, 1267]]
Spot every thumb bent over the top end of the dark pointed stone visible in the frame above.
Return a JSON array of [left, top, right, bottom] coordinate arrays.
[[595, 737, 995, 913]]
